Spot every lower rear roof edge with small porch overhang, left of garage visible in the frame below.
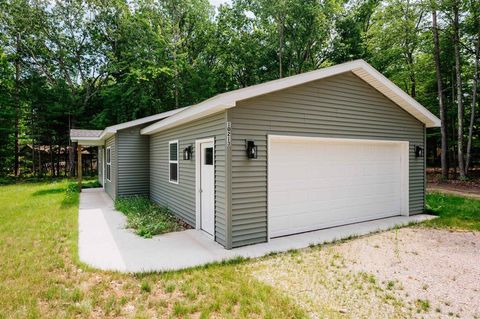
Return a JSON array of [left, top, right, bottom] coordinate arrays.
[[70, 108, 185, 145]]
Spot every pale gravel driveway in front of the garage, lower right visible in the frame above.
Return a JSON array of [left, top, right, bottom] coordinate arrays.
[[251, 228, 480, 318]]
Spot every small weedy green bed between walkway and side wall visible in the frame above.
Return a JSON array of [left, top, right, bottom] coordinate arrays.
[[115, 196, 184, 238]]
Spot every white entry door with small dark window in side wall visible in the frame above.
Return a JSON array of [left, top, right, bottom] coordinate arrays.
[[199, 142, 215, 236]]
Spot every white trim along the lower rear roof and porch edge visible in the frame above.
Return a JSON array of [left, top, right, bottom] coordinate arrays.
[[71, 108, 185, 145]]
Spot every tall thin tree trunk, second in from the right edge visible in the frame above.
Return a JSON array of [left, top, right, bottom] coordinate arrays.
[[453, 0, 466, 179]]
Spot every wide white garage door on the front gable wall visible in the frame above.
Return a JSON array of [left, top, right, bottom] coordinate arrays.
[[268, 136, 408, 237]]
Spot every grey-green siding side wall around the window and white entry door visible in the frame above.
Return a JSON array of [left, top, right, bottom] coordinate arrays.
[[150, 112, 226, 246]]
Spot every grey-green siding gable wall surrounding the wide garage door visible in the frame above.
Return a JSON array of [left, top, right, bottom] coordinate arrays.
[[228, 72, 425, 247]]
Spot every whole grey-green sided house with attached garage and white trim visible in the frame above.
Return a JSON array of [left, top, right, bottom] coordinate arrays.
[[72, 60, 440, 249]]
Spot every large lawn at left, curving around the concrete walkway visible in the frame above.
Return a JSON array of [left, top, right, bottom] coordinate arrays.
[[0, 181, 306, 318]]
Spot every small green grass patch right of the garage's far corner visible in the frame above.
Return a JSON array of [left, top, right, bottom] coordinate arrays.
[[422, 193, 480, 231]]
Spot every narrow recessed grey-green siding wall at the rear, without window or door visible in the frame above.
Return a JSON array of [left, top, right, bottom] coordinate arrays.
[[116, 125, 150, 196]]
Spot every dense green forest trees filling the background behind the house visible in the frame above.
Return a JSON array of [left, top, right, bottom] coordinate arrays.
[[0, 0, 480, 180]]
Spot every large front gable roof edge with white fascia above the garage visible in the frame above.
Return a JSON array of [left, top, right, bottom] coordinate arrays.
[[141, 60, 441, 135]]
